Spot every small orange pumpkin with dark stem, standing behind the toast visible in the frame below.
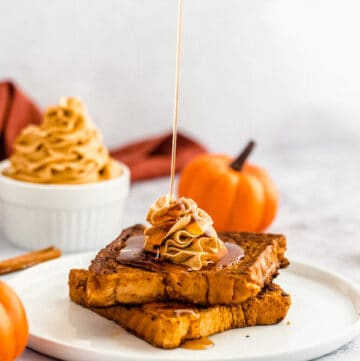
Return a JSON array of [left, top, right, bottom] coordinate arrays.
[[178, 142, 279, 232]]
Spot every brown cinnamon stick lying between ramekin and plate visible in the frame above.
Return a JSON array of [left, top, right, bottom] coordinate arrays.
[[0, 247, 61, 275]]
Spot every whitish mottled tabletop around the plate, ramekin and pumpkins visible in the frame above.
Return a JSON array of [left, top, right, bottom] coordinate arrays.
[[0, 144, 360, 361]]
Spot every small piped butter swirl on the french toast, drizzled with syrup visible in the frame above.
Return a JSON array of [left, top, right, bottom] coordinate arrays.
[[144, 196, 227, 270]]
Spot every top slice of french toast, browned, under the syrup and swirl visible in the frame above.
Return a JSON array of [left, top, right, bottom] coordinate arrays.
[[71, 225, 288, 307]]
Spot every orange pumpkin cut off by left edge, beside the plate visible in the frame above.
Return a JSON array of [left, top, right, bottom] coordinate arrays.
[[0, 281, 29, 361]]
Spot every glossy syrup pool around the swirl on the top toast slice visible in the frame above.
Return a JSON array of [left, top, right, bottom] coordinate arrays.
[[116, 235, 244, 272]]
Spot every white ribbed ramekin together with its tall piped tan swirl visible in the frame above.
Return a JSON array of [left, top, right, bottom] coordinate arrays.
[[0, 98, 130, 252]]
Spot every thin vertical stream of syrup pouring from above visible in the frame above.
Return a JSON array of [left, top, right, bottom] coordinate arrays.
[[170, 0, 183, 199]]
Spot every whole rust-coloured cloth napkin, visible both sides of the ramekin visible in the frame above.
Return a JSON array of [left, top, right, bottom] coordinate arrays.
[[0, 82, 206, 181]]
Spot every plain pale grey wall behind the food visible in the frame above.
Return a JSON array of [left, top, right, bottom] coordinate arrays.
[[0, 0, 360, 154]]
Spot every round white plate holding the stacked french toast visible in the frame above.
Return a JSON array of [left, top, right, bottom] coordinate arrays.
[[10, 254, 360, 361]]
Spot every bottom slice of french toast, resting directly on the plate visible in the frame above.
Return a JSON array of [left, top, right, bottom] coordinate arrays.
[[69, 270, 291, 349]]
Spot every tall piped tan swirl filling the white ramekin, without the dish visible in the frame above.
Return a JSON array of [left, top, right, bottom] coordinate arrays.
[[4, 98, 121, 184]]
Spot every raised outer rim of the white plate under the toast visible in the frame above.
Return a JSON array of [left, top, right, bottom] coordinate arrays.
[[7, 252, 360, 361]]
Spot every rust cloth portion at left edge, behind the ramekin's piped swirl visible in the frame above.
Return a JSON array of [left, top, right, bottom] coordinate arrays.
[[0, 81, 41, 159]]
